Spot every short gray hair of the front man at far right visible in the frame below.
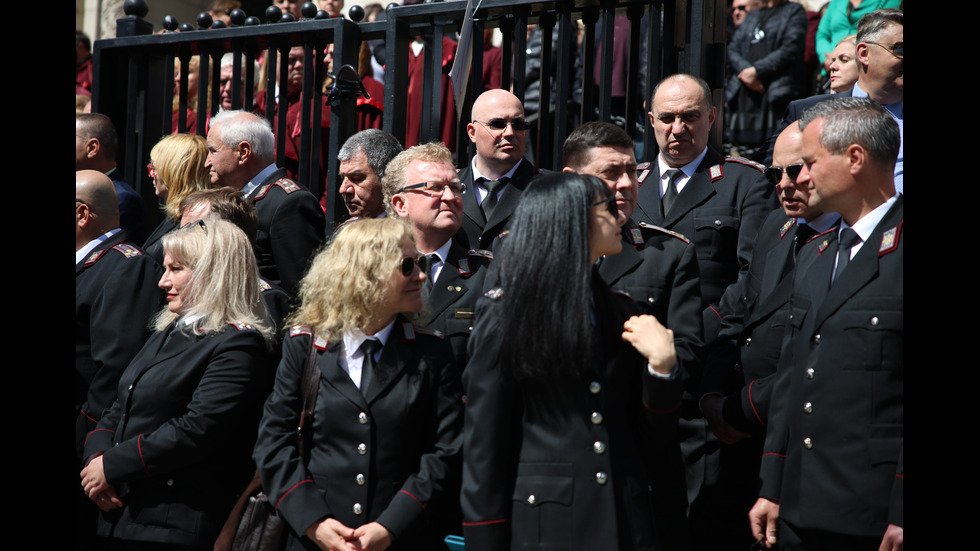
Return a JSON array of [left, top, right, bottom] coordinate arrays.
[[800, 98, 902, 167]]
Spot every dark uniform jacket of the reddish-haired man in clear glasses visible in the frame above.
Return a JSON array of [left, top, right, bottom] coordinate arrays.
[[426, 238, 493, 371]]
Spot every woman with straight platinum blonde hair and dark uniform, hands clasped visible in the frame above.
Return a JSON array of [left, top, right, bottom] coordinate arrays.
[[81, 218, 274, 550]]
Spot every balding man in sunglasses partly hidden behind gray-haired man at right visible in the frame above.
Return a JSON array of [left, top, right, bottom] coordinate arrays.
[[700, 122, 840, 548]]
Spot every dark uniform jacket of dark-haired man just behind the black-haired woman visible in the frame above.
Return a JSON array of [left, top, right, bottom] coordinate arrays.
[[599, 220, 704, 414]]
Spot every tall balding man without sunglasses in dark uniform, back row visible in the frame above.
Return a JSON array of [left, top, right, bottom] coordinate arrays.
[[633, 74, 777, 549]]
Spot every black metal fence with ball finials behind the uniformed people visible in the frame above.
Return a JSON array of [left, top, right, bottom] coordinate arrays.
[[92, 0, 727, 227]]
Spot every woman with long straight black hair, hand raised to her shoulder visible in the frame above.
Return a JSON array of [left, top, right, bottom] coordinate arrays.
[[462, 173, 683, 551]]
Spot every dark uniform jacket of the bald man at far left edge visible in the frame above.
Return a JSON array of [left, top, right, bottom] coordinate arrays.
[[75, 231, 164, 453]]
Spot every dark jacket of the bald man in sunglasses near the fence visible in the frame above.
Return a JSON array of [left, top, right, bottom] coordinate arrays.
[[458, 159, 538, 251]]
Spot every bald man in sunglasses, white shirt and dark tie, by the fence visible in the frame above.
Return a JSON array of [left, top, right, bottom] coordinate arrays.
[[459, 90, 538, 250]]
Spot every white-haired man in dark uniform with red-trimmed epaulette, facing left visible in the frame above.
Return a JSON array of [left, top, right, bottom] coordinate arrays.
[[205, 111, 326, 296]]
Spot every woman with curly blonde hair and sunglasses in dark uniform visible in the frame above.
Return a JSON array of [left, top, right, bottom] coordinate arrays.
[[254, 218, 463, 551]]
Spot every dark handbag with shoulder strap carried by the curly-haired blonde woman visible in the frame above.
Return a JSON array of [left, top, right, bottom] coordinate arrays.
[[214, 334, 320, 551]]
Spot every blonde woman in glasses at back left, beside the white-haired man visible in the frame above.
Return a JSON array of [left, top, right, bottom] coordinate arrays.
[[143, 134, 211, 264]]
